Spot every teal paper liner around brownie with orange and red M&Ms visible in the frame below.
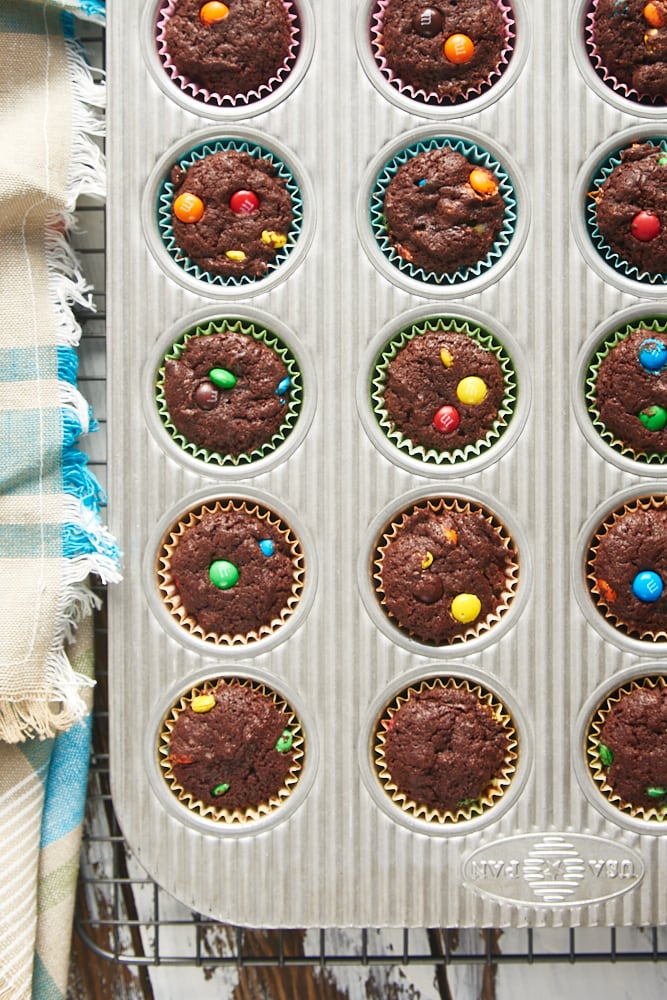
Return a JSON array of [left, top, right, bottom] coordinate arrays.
[[156, 137, 303, 288]]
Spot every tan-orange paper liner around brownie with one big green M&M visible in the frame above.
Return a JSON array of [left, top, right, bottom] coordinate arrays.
[[155, 499, 306, 647]]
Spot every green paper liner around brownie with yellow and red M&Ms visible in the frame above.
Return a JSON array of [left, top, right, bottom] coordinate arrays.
[[371, 316, 518, 466]]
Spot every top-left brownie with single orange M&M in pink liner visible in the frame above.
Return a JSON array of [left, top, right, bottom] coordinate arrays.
[[162, 0, 292, 97]]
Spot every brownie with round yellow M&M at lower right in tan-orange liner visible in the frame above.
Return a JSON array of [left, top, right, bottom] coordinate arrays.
[[375, 501, 517, 646]]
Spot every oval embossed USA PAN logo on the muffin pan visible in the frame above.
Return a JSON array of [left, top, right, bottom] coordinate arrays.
[[463, 833, 644, 906]]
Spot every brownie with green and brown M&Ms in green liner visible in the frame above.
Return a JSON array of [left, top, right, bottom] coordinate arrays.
[[164, 329, 290, 456]]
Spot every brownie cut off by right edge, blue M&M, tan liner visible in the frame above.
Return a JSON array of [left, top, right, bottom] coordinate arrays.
[[588, 497, 667, 640]]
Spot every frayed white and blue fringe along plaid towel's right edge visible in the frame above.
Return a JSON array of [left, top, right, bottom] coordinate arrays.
[[0, 27, 121, 743]]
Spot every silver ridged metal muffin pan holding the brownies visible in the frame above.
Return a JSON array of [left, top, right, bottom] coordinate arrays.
[[107, 0, 667, 927]]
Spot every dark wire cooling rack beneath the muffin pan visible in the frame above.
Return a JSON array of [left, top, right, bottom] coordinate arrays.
[[73, 21, 667, 976]]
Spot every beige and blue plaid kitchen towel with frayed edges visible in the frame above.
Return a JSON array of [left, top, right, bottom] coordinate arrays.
[[0, 0, 118, 1000]]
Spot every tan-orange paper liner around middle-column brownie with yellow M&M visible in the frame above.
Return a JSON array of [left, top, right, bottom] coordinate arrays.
[[371, 497, 519, 648]]
